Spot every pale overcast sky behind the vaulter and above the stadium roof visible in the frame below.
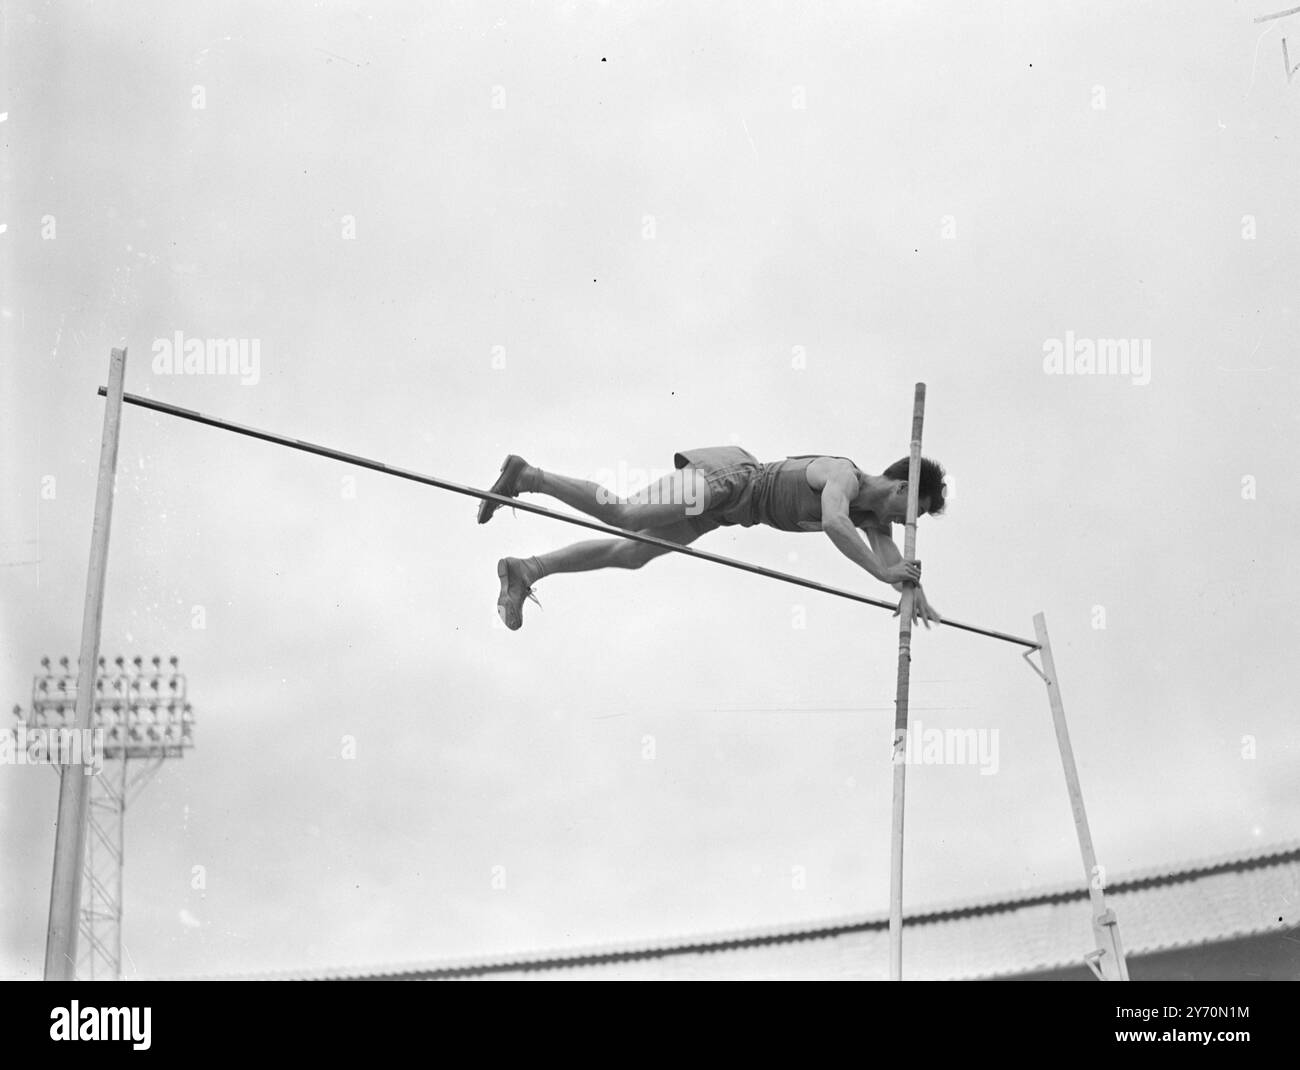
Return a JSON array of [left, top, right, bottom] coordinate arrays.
[[0, 0, 1300, 976]]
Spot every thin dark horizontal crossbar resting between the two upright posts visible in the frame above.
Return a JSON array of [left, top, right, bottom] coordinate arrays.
[[99, 386, 1039, 650]]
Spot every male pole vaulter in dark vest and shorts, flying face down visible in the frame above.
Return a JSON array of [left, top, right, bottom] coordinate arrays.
[[478, 446, 945, 631]]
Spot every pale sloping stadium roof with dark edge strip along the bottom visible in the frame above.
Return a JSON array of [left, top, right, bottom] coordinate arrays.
[[185, 841, 1300, 980]]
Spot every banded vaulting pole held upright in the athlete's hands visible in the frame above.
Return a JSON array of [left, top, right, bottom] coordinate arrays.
[[889, 382, 926, 980]]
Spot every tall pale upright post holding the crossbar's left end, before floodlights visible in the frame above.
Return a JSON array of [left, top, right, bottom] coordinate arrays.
[[46, 350, 126, 980]]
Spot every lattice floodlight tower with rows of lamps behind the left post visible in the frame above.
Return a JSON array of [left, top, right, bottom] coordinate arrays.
[[13, 657, 194, 980]]
